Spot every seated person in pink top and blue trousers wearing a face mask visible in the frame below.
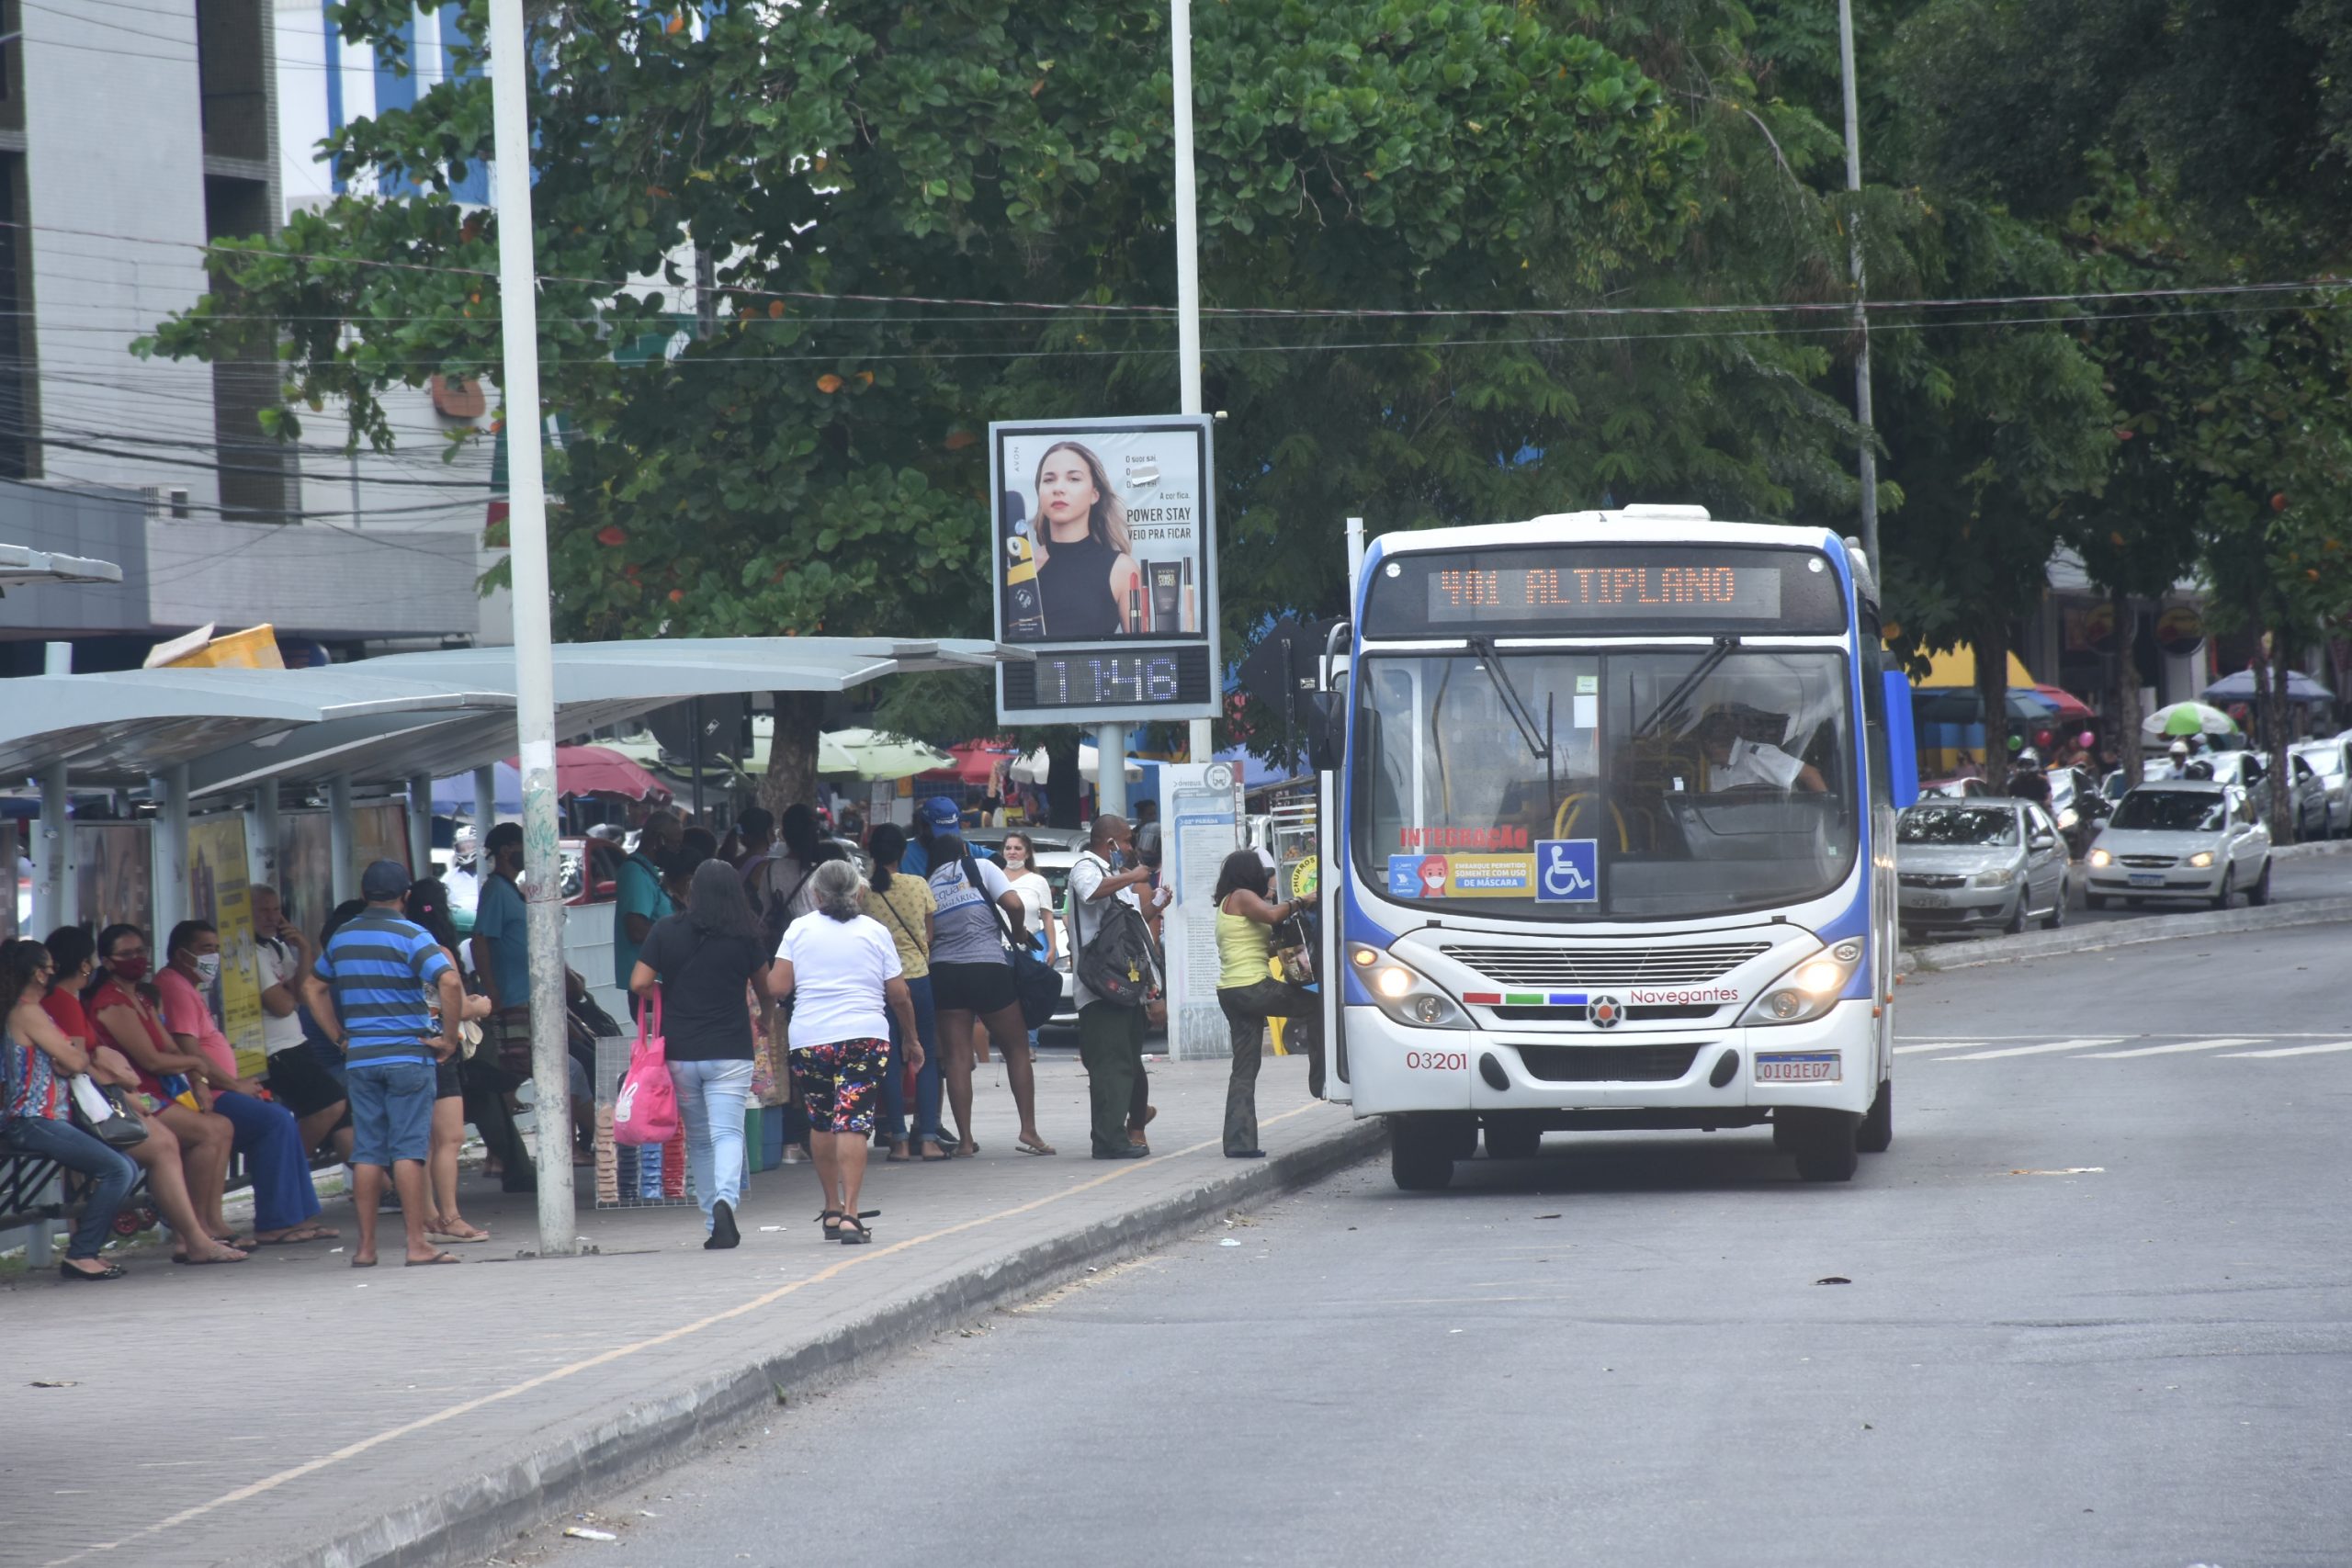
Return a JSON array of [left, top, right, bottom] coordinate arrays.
[[155, 919, 339, 1246]]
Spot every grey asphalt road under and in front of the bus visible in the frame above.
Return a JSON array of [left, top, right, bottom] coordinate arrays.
[[501, 926, 2352, 1568]]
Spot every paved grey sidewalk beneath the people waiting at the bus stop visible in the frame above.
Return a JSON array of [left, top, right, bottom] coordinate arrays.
[[0, 1055, 1381, 1568]]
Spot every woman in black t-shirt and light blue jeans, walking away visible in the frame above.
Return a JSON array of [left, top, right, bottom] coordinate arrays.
[[628, 861, 769, 1253]]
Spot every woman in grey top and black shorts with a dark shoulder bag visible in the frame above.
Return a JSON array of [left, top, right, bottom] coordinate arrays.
[[932, 832, 1056, 1155]]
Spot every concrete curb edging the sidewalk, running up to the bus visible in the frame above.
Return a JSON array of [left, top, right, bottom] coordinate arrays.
[[268, 1119, 1387, 1568]]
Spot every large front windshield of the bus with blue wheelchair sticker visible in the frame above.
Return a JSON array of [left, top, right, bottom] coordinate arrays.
[[1355, 642, 1856, 919]]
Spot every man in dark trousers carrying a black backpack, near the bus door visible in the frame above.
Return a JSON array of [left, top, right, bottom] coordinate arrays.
[[1070, 816, 1158, 1159]]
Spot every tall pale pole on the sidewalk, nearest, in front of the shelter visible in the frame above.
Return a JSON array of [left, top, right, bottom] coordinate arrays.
[[489, 0, 576, 1258]]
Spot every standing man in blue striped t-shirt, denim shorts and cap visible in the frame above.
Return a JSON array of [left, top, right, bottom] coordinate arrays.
[[303, 861, 466, 1269]]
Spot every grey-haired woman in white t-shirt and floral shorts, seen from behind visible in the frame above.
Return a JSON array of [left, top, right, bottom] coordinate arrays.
[[767, 861, 922, 1246]]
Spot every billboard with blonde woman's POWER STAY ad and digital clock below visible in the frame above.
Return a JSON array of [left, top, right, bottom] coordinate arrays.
[[988, 413, 1216, 722]]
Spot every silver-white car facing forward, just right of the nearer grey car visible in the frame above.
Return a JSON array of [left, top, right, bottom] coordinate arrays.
[[2084, 778, 2269, 909]]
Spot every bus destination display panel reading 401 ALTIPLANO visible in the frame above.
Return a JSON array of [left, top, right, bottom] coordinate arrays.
[[1364, 543, 1847, 637]]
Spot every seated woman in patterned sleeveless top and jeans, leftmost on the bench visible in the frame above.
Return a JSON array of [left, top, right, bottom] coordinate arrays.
[[0, 942, 139, 1279]]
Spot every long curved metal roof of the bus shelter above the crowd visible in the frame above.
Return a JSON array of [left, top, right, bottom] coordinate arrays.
[[0, 637, 1023, 795]]
